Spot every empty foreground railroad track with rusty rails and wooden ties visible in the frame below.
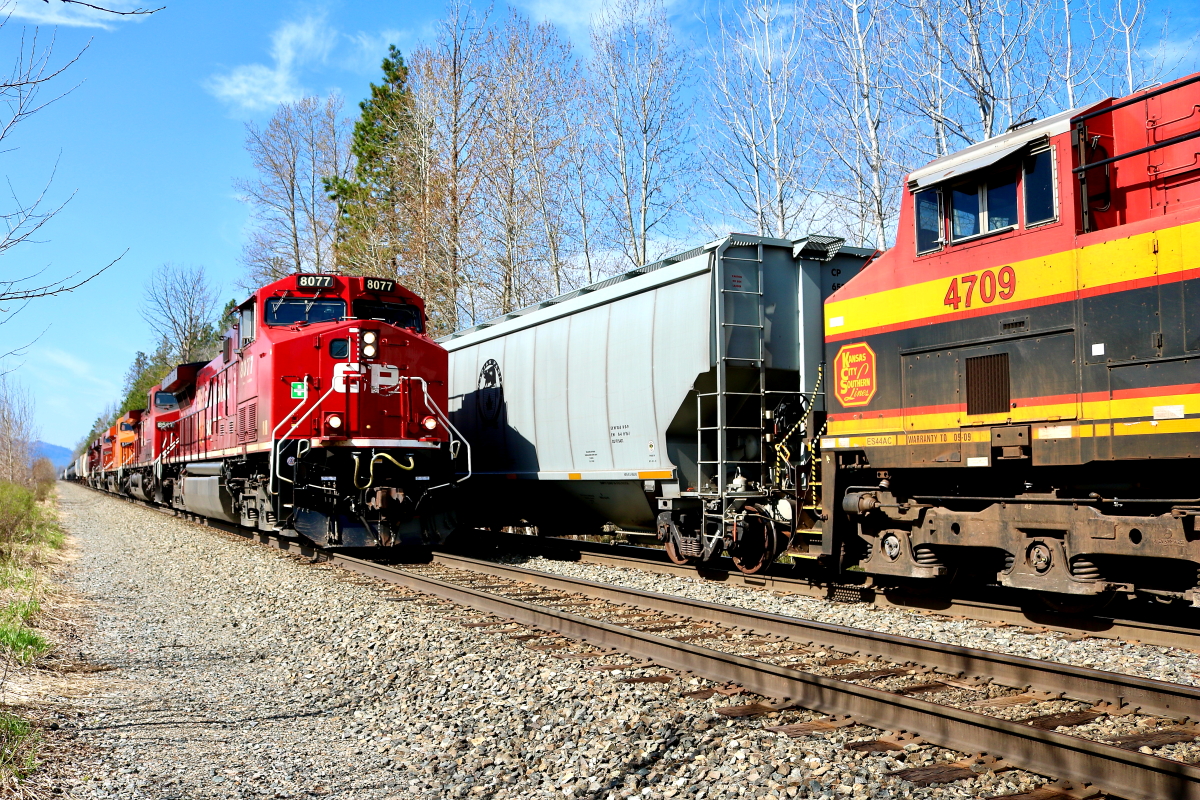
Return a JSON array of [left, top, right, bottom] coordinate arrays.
[[112, 496, 1200, 800]]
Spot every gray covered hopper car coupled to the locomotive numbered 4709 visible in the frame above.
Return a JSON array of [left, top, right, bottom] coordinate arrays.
[[442, 234, 871, 571]]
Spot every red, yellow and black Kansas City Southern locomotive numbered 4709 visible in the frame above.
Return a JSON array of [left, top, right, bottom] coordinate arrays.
[[821, 76, 1200, 599]]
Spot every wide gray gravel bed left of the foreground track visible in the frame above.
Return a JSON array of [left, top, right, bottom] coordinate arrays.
[[46, 486, 1060, 800]]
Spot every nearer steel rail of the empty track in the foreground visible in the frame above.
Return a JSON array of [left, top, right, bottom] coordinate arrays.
[[329, 553, 1200, 800]]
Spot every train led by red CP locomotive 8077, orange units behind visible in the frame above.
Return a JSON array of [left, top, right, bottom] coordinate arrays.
[[81, 275, 470, 547]]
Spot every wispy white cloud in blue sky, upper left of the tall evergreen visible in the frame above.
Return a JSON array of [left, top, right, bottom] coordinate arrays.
[[206, 17, 337, 112]]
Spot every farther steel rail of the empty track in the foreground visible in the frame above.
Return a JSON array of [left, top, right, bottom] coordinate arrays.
[[433, 553, 1200, 720]]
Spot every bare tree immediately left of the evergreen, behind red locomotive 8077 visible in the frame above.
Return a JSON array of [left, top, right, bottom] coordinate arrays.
[[235, 94, 349, 288]]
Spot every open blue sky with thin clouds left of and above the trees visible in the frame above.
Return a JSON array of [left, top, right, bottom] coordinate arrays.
[[0, 0, 1194, 447]]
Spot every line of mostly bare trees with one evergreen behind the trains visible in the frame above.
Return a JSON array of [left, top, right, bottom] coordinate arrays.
[[238, 0, 1192, 333]]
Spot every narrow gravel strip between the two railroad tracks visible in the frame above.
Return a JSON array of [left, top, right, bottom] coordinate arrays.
[[489, 557, 1200, 686]]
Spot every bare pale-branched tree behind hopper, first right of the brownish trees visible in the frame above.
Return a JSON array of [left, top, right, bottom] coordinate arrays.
[[590, 0, 692, 266]]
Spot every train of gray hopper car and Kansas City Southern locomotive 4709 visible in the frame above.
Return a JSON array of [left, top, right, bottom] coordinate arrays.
[[443, 76, 1200, 604]]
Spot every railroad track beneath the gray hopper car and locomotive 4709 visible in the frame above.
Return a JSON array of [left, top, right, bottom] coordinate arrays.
[[470, 534, 1200, 650]]
